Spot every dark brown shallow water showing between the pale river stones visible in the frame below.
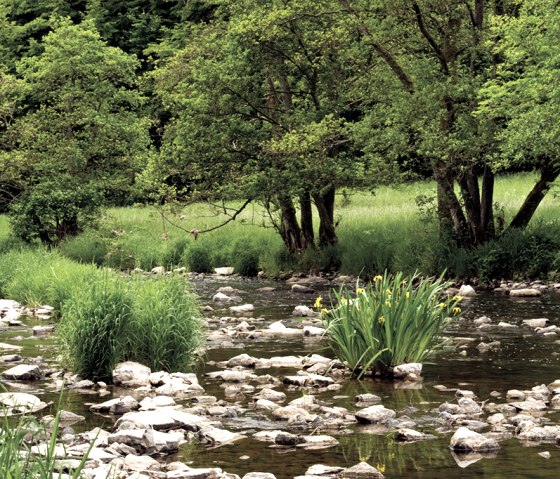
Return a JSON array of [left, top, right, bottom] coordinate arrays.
[[0, 278, 560, 479]]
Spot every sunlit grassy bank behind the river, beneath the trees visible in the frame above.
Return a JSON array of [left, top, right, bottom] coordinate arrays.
[[0, 173, 560, 280]]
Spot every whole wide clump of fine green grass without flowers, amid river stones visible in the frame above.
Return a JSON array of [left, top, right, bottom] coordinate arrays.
[[57, 273, 202, 382]]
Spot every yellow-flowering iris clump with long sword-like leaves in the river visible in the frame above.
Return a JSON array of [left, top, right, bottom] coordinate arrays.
[[322, 273, 461, 378]]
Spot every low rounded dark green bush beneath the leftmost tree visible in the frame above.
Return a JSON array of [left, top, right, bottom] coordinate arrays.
[[10, 175, 101, 245]]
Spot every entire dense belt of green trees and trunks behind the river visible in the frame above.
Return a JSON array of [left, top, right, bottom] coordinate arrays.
[[0, 0, 560, 262]]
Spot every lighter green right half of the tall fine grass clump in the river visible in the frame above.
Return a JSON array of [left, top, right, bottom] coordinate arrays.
[[125, 276, 202, 372]]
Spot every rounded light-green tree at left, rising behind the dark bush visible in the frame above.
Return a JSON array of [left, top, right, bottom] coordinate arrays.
[[3, 19, 149, 242]]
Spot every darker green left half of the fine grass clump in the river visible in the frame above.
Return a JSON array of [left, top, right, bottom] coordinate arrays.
[[58, 273, 132, 381]]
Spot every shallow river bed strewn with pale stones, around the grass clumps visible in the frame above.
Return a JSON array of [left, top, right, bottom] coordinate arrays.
[[0, 277, 560, 479]]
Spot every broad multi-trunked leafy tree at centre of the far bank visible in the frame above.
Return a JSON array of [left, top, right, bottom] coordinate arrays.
[[151, 0, 363, 253]]
